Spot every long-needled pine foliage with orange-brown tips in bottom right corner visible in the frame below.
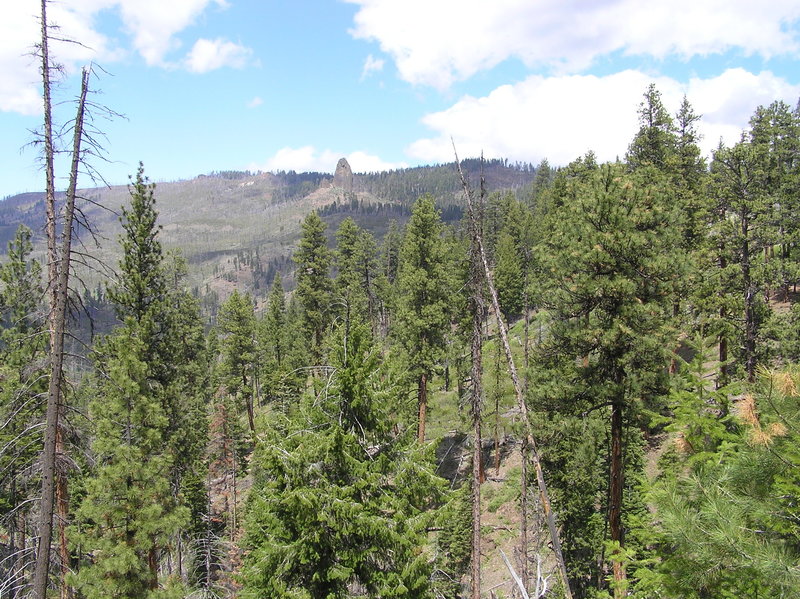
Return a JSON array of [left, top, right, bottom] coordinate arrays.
[[652, 371, 800, 598]]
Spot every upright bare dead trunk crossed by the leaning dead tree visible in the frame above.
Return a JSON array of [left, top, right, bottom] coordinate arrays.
[[470, 164, 484, 599]]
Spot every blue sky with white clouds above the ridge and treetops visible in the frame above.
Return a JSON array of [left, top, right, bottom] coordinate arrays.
[[0, 0, 800, 198]]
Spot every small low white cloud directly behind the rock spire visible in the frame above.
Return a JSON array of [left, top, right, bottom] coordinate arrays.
[[253, 146, 407, 173]]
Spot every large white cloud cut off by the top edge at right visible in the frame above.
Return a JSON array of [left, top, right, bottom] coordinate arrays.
[[347, 0, 800, 89]]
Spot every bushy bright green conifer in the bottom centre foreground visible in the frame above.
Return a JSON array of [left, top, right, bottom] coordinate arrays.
[[242, 324, 446, 599]]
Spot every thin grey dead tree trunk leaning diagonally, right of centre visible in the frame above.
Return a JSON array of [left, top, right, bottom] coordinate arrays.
[[453, 143, 572, 599]]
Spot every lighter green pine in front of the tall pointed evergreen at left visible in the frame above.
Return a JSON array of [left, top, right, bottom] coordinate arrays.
[[70, 326, 189, 599]]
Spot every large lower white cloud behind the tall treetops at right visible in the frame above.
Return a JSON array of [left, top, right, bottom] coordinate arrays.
[[407, 69, 800, 169]]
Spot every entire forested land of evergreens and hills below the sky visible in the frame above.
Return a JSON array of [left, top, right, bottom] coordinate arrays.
[[0, 76, 800, 599]]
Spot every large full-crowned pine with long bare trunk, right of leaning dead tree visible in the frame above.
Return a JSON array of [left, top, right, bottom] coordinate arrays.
[[539, 164, 681, 596]]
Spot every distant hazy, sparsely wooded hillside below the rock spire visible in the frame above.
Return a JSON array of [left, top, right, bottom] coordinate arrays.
[[0, 160, 534, 311]]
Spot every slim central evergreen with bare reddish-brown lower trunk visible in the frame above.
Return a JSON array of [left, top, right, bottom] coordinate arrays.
[[395, 196, 451, 442]]
